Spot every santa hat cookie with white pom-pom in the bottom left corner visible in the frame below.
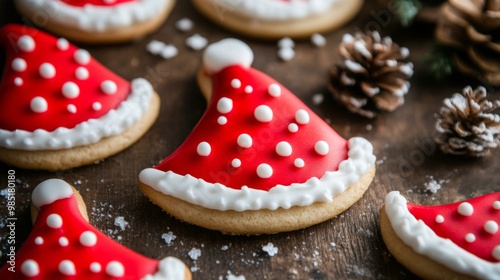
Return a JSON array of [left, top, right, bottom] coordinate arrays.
[[0, 179, 191, 280]]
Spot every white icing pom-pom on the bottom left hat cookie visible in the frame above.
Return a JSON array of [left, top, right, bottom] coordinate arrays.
[[31, 179, 73, 208]]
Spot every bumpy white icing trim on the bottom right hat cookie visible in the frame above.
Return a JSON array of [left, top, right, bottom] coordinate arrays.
[[385, 191, 500, 279]]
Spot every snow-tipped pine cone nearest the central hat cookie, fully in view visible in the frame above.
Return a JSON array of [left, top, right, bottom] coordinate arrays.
[[328, 32, 413, 118]]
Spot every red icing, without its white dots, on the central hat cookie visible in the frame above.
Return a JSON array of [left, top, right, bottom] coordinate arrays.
[[155, 66, 347, 190]]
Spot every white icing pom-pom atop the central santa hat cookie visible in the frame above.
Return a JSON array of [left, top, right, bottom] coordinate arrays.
[[203, 38, 253, 74]]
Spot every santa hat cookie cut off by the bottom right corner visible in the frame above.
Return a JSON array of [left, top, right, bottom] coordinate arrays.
[[380, 192, 500, 279]]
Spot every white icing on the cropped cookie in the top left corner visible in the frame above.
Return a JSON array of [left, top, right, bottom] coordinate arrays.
[[17, 0, 171, 32]]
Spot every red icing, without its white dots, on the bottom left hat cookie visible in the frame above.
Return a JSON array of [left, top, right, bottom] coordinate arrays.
[[0, 188, 159, 280]]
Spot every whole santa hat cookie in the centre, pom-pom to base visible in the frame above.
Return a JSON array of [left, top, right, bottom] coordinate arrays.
[[139, 39, 375, 234]]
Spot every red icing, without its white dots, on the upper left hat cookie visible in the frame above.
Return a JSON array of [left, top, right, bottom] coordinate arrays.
[[0, 24, 130, 131]]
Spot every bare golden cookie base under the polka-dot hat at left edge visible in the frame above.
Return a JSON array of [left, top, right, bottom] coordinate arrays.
[[0, 92, 160, 171]]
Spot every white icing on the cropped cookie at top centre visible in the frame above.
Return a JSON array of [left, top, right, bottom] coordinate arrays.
[[210, 0, 342, 21]]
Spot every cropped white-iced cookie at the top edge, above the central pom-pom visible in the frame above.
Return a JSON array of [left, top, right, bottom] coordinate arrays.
[[193, 0, 363, 39]]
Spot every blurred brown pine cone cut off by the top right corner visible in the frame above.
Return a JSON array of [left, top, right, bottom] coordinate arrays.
[[436, 0, 500, 86]]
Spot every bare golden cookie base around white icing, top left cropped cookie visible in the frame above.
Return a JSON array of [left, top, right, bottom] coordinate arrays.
[[14, 0, 176, 44]]
